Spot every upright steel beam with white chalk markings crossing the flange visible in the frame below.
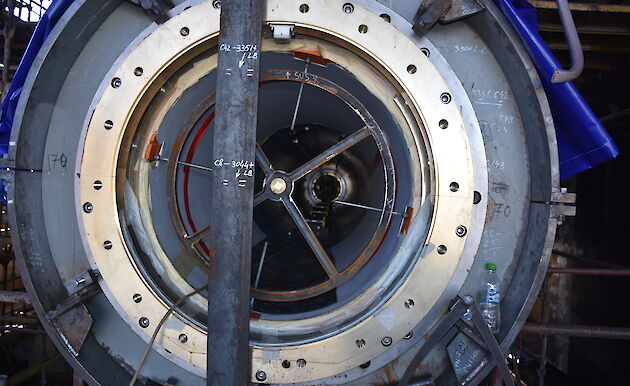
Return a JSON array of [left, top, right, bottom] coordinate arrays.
[[207, 0, 264, 386]]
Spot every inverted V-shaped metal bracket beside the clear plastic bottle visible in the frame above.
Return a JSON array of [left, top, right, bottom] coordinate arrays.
[[398, 296, 514, 386]]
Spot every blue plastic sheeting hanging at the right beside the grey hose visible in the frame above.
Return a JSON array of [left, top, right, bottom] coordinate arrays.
[[494, 0, 619, 179]]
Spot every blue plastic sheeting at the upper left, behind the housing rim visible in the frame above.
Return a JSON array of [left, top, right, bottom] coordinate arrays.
[[0, 0, 74, 155]]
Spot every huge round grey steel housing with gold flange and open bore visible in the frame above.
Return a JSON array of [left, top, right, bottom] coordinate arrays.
[[9, 0, 558, 385]]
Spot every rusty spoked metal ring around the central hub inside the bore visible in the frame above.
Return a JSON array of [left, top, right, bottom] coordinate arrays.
[[167, 69, 396, 302]]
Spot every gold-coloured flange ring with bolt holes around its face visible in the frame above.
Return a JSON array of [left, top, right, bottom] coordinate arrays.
[[76, 0, 487, 383]]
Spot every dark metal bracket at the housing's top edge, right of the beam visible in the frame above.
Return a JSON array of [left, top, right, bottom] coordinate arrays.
[[413, 0, 485, 35]]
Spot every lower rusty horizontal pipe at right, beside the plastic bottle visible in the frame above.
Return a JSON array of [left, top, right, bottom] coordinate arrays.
[[521, 323, 630, 340]]
